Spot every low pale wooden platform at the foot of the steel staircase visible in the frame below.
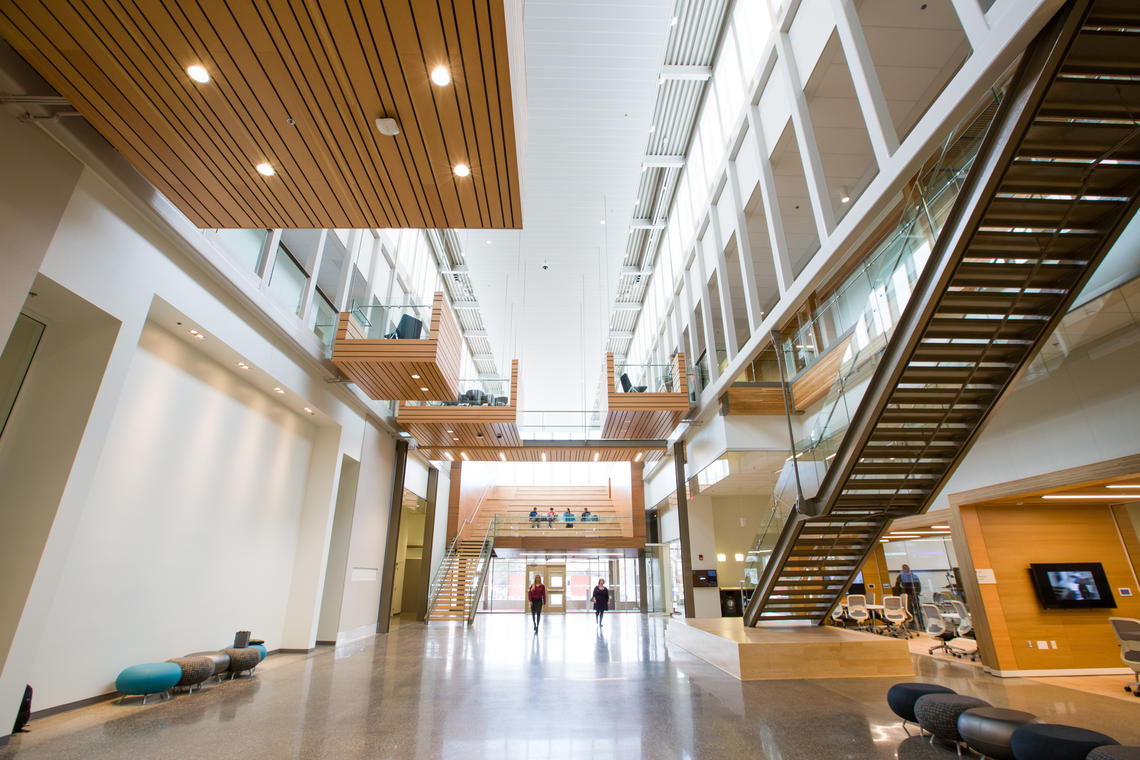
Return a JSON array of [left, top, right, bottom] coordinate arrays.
[[665, 618, 914, 681]]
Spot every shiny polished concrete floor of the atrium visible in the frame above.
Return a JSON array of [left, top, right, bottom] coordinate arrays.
[[0, 613, 1140, 760]]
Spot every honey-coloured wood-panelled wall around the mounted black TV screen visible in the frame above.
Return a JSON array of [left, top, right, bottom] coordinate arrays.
[[960, 505, 1140, 671]]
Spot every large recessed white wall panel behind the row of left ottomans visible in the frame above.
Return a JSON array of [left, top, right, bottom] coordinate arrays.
[[32, 327, 314, 706]]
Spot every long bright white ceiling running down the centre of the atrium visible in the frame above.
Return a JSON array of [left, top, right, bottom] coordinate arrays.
[[461, 0, 674, 409]]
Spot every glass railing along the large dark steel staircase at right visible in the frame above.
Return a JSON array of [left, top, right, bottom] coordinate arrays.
[[746, 87, 998, 581]]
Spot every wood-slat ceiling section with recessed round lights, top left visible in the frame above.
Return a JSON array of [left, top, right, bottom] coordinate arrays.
[[0, 0, 522, 229]]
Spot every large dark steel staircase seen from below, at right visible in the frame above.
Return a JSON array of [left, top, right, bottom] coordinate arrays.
[[744, 0, 1140, 626]]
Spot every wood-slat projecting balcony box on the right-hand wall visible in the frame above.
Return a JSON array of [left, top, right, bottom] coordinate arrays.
[[602, 353, 689, 440]]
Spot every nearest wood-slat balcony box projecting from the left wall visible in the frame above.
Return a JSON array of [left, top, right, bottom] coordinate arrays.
[[333, 293, 463, 401]]
